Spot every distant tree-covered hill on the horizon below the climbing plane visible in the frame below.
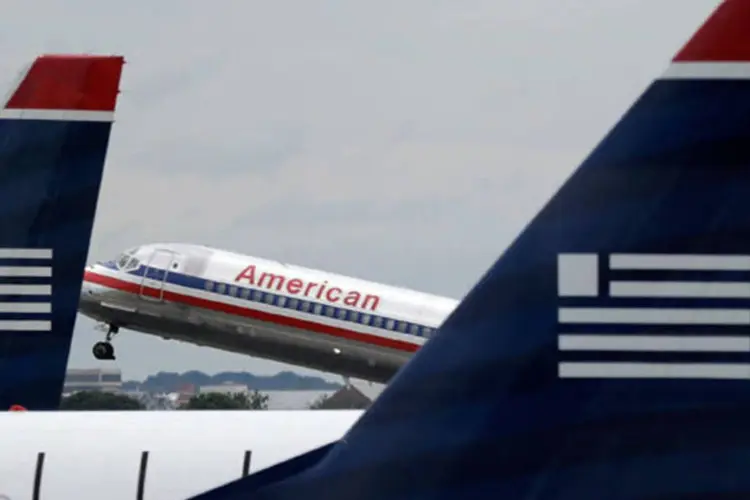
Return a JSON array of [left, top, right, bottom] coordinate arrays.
[[122, 370, 342, 392]]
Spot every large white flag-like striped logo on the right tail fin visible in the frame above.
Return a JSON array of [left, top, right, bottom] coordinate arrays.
[[557, 254, 750, 380]]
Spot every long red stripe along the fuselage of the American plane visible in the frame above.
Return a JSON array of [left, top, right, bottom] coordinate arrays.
[[83, 271, 421, 352]]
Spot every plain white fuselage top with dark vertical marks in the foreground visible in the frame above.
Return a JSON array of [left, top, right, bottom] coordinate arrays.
[[0, 410, 362, 500]]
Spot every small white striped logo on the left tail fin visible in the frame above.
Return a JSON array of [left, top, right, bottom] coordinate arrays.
[[0, 248, 52, 332]]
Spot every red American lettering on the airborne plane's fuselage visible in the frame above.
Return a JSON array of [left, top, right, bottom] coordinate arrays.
[[234, 265, 380, 311]]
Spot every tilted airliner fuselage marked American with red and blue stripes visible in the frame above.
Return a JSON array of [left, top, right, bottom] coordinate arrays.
[[80, 244, 457, 383]]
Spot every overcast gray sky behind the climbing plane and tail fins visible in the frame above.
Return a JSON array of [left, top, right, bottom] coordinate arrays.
[[0, 0, 719, 378]]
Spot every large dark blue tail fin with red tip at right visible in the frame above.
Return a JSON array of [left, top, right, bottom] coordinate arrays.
[[191, 0, 750, 500]]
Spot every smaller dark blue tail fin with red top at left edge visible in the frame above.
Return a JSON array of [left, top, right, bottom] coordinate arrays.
[[0, 55, 124, 410]]
